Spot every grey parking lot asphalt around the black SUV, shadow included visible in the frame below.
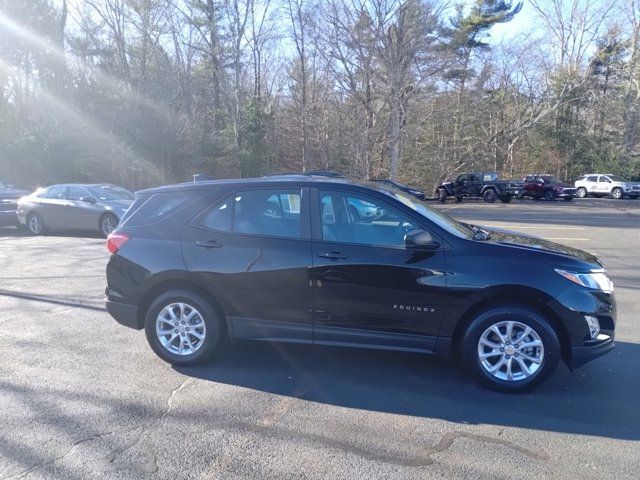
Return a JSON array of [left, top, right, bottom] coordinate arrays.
[[0, 199, 640, 480]]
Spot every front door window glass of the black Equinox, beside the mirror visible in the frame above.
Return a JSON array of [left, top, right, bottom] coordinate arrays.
[[320, 191, 416, 247]]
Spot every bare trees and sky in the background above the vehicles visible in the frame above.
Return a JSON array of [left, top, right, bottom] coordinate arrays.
[[0, 0, 640, 189]]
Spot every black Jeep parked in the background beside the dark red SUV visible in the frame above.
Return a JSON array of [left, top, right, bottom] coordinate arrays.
[[436, 172, 520, 203]]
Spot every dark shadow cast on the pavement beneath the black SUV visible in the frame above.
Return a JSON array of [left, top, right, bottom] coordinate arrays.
[[175, 342, 640, 440]]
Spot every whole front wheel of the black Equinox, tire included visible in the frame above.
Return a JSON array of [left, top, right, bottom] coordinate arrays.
[[460, 305, 561, 392]]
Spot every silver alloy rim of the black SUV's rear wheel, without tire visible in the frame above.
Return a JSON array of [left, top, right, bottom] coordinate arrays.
[[156, 302, 207, 356]]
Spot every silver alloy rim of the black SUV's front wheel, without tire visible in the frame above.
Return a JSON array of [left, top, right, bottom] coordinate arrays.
[[478, 321, 544, 382]]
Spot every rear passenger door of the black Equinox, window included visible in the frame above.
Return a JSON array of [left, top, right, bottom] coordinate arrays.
[[182, 186, 313, 343]]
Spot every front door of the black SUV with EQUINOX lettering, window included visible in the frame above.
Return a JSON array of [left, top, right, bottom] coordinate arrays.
[[312, 189, 446, 352]]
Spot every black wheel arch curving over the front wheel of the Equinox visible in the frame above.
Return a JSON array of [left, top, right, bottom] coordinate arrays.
[[450, 286, 571, 360]]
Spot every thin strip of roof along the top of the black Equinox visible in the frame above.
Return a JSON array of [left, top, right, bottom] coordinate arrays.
[[136, 174, 388, 194]]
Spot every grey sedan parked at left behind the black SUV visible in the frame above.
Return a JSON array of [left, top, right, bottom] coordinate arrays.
[[17, 184, 134, 237]]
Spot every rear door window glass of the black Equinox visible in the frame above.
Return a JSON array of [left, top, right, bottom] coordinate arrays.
[[233, 189, 301, 238]]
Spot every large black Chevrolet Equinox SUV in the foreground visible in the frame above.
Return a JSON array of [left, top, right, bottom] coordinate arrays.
[[106, 175, 616, 391]]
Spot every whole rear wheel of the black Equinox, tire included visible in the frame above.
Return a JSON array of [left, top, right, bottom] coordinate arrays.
[[144, 290, 223, 365]]
